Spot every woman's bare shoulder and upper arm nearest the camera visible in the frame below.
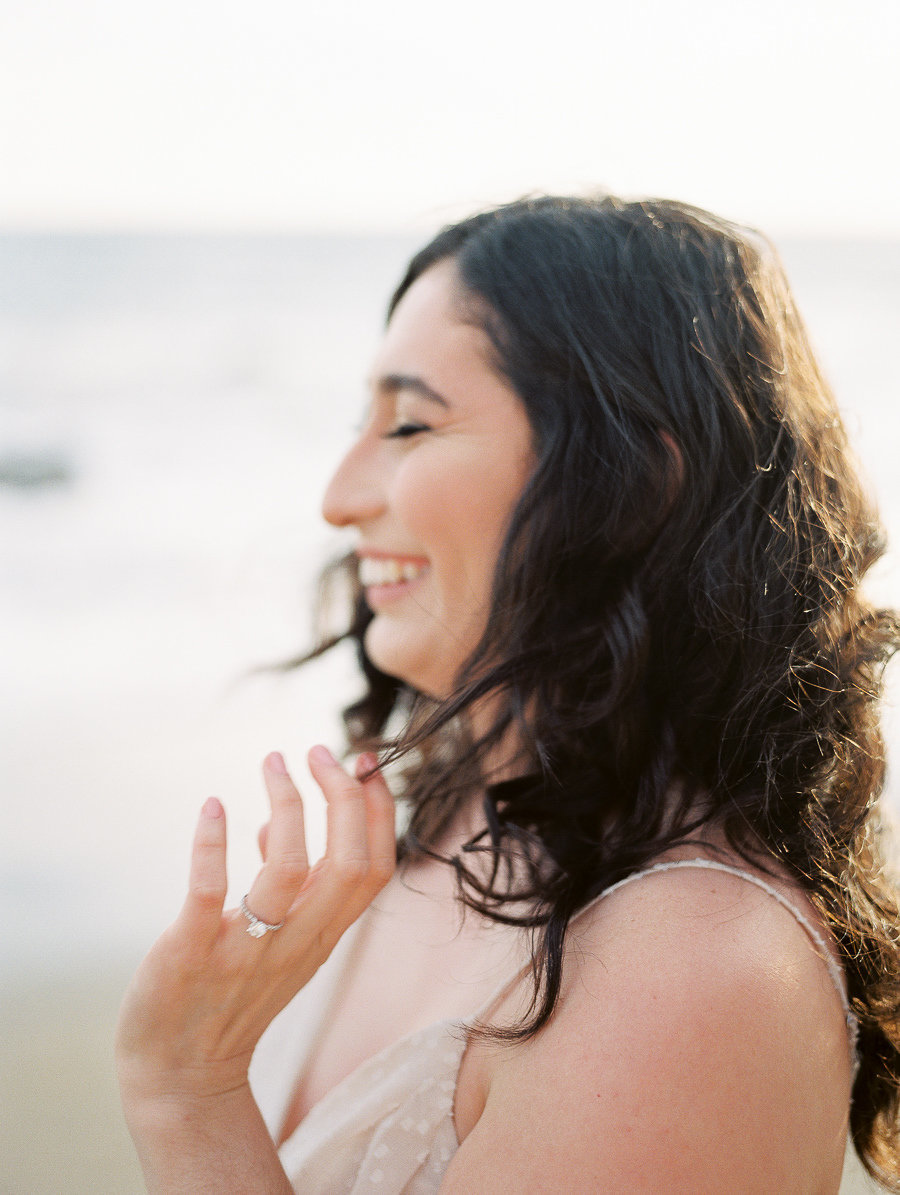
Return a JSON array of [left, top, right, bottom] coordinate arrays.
[[447, 868, 850, 1193]]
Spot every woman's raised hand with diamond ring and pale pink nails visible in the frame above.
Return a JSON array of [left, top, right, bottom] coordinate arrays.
[[116, 747, 396, 1189]]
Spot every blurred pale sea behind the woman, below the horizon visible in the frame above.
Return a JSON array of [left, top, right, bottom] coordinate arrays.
[[0, 228, 900, 986]]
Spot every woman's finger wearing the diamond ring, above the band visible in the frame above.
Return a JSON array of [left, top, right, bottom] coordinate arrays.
[[247, 752, 310, 924]]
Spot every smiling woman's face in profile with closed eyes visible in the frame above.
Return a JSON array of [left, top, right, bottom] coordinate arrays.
[[323, 262, 534, 697]]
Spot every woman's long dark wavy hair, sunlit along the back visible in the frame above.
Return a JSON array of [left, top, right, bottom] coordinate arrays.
[[298, 197, 900, 1181]]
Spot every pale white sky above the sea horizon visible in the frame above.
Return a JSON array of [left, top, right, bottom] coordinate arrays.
[[0, 0, 900, 237]]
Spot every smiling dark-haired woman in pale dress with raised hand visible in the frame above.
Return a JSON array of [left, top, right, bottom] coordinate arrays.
[[118, 191, 900, 1193]]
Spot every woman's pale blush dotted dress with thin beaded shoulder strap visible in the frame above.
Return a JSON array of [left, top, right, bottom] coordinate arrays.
[[250, 859, 857, 1195]]
